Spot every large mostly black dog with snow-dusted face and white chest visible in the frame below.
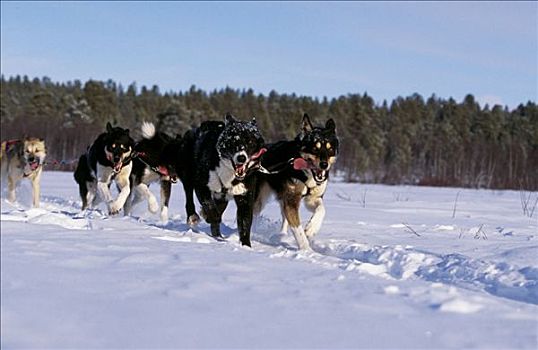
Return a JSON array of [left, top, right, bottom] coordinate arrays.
[[184, 114, 265, 246]]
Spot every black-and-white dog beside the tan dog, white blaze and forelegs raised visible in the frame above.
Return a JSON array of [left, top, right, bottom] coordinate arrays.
[[74, 123, 134, 215]]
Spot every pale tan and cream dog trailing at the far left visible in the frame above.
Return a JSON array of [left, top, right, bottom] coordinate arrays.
[[0, 137, 47, 208]]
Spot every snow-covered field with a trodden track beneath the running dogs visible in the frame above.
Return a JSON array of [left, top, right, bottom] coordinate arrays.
[[1, 172, 538, 349]]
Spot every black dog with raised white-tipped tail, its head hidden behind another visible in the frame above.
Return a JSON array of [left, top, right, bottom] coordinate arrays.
[[124, 122, 182, 222]]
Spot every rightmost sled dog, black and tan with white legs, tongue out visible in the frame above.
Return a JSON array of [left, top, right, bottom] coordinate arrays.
[[255, 113, 339, 249]]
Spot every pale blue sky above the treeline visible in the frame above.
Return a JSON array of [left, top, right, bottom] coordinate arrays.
[[1, 1, 538, 108]]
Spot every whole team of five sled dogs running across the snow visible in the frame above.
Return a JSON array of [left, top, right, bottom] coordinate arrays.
[[0, 114, 339, 249]]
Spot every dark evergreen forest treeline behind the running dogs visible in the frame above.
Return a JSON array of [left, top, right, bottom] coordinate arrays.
[[0, 76, 538, 190]]
